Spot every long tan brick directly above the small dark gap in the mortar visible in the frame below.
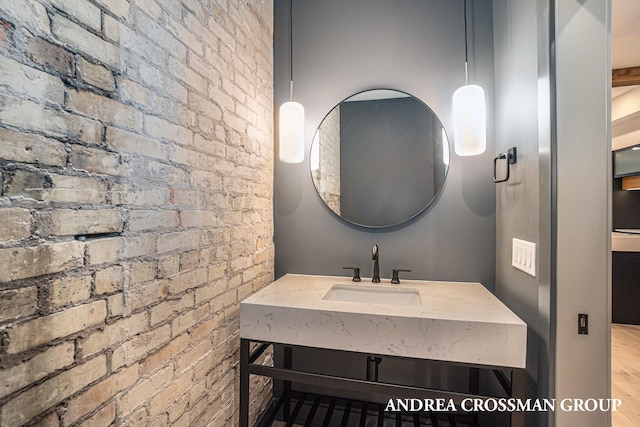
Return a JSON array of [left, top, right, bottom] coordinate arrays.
[[37, 209, 123, 236]]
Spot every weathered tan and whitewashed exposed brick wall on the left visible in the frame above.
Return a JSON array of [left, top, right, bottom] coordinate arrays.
[[0, 0, 273, 427]]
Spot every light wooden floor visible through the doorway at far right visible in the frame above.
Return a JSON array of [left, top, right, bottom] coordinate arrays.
[[611, 324, 640, 427]]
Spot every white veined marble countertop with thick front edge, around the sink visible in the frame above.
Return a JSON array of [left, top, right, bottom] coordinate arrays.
[[240, 274, 527, 368]]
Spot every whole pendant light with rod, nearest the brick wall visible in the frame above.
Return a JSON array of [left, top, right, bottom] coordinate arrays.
[[278, 0, 304, 163]]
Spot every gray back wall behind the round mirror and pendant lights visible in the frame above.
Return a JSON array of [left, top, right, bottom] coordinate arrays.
[[274, 0, 495, 289]]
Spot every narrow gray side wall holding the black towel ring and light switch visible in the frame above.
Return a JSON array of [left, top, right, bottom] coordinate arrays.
[[493, 0, 552, 426]]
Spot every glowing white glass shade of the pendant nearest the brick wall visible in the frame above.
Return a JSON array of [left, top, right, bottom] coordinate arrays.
[[278, 101, 304, 163]]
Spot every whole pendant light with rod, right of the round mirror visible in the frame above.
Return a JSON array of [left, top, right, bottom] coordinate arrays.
[[453, 0, 487, 156]]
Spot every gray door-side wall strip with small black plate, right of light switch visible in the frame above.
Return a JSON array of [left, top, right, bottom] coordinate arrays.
[[554, 0, 612, 427]]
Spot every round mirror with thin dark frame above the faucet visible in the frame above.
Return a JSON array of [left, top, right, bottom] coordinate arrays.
[[310, 89, 449, 227]]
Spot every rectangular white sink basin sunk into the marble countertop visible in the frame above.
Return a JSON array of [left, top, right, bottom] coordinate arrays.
[[323, 285, 422, 306]]
